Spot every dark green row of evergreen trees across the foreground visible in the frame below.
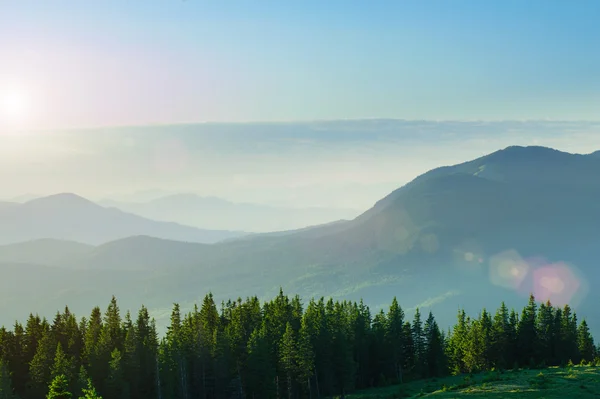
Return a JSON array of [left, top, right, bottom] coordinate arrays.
[[0, 291, 599, 399]]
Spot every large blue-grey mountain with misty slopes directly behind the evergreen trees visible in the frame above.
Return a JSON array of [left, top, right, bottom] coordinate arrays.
[[0, 147, 600, 331]]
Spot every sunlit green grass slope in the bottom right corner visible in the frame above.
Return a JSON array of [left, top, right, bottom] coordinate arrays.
[[336, 366, 600, 399]]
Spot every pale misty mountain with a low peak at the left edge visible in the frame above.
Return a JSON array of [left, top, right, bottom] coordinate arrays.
[[0, 194, 244, 245]]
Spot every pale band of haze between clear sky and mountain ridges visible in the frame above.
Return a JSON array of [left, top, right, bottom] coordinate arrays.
[[0, 120, 600, 211]]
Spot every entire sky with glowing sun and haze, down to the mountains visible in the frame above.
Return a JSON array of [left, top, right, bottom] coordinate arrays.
[[0, 0, 600, 209]]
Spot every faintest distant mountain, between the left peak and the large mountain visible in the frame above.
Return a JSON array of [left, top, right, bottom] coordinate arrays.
[[99, 193, 361, 232]]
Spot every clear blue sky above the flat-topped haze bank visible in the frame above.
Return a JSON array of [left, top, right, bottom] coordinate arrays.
[[0, 0, 600, 128]]
